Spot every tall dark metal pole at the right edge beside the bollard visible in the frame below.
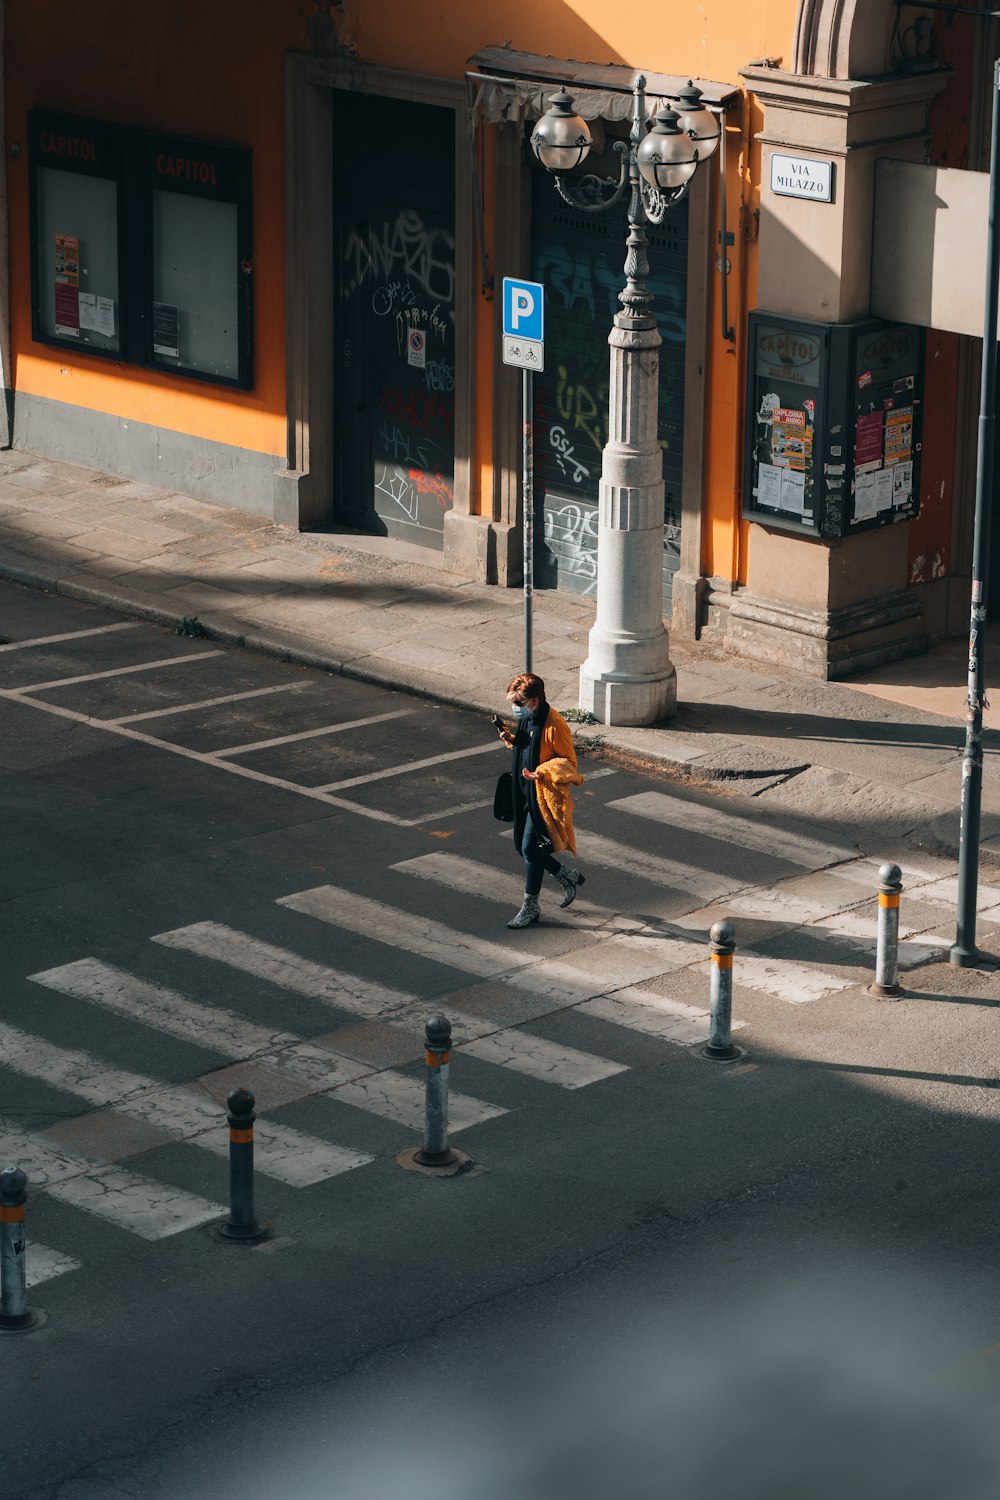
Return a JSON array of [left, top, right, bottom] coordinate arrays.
[[949, 59, 1000, 969]]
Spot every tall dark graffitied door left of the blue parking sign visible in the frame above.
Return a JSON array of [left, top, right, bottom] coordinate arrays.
[[333, 93, 454, 551]]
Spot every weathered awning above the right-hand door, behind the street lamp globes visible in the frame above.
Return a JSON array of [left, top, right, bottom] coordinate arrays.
[[466, 47, 739, 125]]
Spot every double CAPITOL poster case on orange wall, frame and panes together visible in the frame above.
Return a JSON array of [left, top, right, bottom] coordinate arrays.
[[28, 111, 253, 390]]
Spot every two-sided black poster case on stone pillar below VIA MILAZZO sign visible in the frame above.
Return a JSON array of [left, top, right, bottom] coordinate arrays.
[[744, 312, 924, 537]]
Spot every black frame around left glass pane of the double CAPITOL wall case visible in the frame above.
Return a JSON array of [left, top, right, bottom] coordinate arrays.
[[28, 110, 132, 365]]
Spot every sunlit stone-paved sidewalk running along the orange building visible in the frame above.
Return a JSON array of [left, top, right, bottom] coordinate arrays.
[[0, 450, 1000, 869]]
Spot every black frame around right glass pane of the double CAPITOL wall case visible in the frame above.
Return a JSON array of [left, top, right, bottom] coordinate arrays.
[[142, 134, 253, 390]]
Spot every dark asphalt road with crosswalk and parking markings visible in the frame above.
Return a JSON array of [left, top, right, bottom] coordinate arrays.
[[0, 585, 1000, 1500]]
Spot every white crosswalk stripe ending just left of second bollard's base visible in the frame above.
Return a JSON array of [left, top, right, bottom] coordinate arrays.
[[0, 1116, 223, 1239]]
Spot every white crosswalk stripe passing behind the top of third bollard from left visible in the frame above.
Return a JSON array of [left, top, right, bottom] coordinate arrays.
[[154, 923, 621, 1100]]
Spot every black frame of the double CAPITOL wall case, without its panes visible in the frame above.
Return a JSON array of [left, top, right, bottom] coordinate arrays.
[[28, 110, 253, 390]]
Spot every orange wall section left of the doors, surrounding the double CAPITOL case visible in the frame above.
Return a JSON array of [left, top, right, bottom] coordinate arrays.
[[4, 0, 306, 455]]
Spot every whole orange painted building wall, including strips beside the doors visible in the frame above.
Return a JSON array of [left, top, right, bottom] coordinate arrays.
[[6, 0, 798, 540]]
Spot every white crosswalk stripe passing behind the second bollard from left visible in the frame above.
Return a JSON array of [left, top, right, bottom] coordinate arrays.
[[0, 1022, 372, 1188]]
